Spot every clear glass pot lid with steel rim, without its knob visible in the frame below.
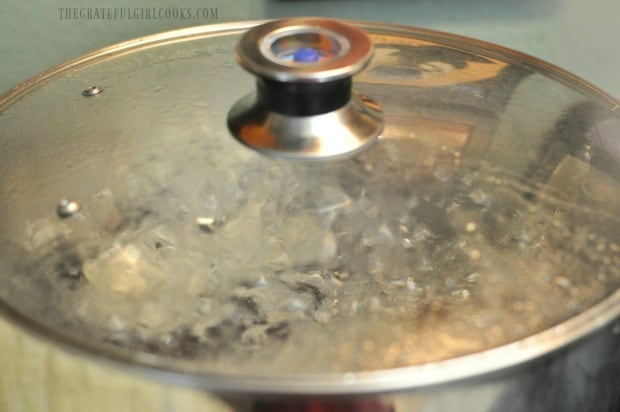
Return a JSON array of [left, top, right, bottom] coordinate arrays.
[[0, 18, 620, 393]]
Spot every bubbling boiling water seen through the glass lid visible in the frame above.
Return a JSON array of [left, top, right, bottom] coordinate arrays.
[[5, 140, 620, 373]]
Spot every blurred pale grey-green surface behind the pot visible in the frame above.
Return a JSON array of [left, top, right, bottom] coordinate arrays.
[[0, 0, 620, 98]]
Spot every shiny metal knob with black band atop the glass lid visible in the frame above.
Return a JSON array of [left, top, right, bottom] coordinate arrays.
[[228, 18, 383, 160]]
